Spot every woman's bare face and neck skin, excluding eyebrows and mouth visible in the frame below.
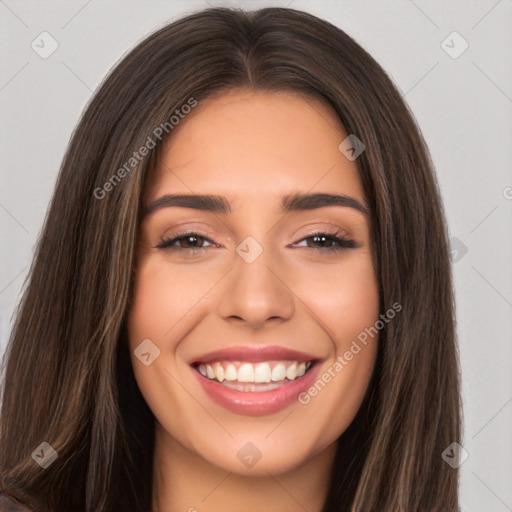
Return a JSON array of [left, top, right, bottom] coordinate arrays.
[[128, 90, 379, 512]]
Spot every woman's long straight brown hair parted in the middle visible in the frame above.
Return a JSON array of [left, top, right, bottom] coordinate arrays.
[[0, 8, 462, 512]]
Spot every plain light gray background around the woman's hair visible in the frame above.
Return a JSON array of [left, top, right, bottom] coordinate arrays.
[[0, 0, 512, 512]]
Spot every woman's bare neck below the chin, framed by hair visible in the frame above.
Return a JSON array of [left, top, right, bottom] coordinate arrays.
[[153, 422, 337, 512]]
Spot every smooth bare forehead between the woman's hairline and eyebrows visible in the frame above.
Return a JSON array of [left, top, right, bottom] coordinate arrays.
[[147, 90, 364, 207]]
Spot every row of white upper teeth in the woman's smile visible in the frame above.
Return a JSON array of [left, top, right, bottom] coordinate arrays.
[[198, 361, 311, 382]]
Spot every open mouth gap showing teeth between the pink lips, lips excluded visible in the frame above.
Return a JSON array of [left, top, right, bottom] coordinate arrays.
[[193, 361, 314, 392]]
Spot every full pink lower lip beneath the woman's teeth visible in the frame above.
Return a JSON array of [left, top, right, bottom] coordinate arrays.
[[193, 363, 320, 416]]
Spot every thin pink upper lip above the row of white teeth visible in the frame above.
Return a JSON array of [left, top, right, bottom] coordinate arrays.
[[192, 345, 317, 364]]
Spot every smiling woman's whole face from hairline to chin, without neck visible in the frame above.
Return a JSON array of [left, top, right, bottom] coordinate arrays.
[[128, 90, 379, 475]]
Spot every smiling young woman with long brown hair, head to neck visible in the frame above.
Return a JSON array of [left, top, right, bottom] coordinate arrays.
[[0, 8, 461, 512]]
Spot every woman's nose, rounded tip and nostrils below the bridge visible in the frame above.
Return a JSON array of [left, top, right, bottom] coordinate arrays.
[[218, 242, 295, 330]]
